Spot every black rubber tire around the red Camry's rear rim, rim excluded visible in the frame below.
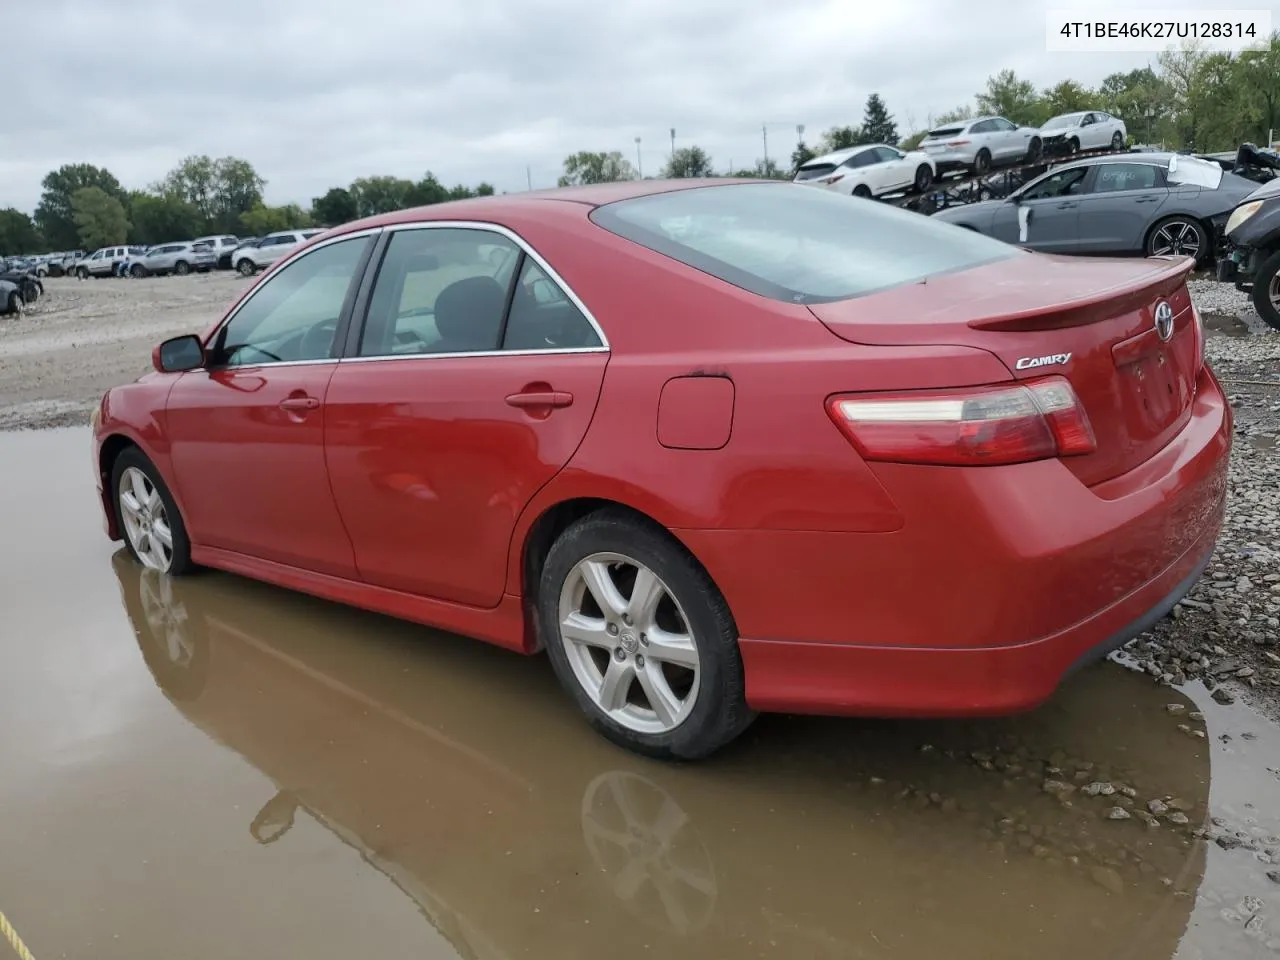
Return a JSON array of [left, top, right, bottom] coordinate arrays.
[[536, 511, 754, 759]]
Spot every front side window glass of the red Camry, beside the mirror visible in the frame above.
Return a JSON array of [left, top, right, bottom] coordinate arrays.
[[214, 237, 370, 366]]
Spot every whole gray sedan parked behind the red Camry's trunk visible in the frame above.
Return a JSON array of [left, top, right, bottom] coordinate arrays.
[[933, 154, 1257, 262]]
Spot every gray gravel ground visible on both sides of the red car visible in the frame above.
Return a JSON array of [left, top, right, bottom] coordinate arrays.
[[0, 271, 1280, 717]]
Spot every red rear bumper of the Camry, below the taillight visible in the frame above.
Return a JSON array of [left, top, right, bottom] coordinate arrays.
[[677, 371, 1231, 716]]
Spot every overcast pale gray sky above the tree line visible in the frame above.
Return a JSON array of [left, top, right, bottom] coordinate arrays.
[[0, 0, 1280, 211]]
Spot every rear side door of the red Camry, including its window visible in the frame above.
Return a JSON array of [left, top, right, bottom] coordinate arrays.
[[325, 224, 608, 607]]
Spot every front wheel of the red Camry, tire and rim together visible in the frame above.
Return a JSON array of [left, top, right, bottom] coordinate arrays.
[[111, 447, 193, 576]]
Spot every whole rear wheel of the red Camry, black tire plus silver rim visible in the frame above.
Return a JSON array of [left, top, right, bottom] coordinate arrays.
[[538, 509, 755, 760]]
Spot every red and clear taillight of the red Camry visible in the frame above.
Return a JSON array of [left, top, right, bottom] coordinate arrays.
[[827, 376, 1097, 466]]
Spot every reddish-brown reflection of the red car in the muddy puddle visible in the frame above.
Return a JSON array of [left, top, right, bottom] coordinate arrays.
[[114, 552, 1208, 960]]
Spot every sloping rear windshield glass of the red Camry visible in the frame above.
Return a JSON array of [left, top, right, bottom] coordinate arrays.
[[591, 183, 1023, 303]]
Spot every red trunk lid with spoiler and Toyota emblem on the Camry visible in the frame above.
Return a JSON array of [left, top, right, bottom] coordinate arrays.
[[810, 253, 1201, 485]]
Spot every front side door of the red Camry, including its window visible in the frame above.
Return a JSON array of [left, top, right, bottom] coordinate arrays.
[[165, 232, 374, 577]]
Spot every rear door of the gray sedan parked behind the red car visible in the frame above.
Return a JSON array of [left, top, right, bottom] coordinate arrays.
[[1079, 163, 1169, 253]]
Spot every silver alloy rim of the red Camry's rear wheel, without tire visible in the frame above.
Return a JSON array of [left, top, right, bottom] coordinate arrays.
[[557, 553, 700, 733]]
